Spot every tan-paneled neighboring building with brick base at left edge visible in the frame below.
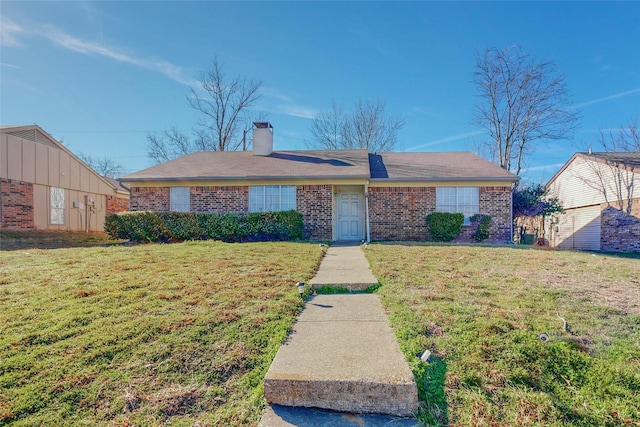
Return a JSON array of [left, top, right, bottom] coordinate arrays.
[[0, 125, 129, 231]]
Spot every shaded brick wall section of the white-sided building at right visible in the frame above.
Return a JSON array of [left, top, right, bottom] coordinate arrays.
[[600, 199, 640, 252]]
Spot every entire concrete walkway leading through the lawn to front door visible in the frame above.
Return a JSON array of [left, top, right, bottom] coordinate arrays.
[[260, 242, 418, 427]]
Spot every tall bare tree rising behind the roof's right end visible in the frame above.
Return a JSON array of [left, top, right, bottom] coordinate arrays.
[[473, 47, 579, 174]]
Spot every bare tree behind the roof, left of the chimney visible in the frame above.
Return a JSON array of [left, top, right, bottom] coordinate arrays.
[[147, 58, 262, 163]]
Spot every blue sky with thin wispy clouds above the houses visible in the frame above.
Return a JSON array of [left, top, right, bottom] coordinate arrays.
[[0, 0, 640, 182]]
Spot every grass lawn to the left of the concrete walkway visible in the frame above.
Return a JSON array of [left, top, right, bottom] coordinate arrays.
[[0, 239, 321, 426]]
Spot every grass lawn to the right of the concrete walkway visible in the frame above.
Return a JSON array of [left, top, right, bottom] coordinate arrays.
[[366, 244, 640, 426]]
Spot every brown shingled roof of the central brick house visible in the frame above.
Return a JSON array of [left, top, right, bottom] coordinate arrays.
[[121, 150, 518, 182]]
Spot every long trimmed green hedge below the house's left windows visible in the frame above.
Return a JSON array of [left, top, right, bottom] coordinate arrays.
[[104, 211, 304, 242]]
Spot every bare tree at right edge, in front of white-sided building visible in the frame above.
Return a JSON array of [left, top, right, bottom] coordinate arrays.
[[574, 119, 640, 214]]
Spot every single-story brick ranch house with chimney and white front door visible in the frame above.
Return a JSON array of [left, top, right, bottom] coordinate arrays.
[[121, 123, 519, 242]]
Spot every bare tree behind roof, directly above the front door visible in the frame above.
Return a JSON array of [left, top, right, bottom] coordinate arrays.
[[309, 99, 404, 152]]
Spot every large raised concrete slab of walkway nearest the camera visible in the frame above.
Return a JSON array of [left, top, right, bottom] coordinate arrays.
[[264, 294, 418, 416]]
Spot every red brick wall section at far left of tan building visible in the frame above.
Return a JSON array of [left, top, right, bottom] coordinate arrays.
[[0, 179, 35, 230]]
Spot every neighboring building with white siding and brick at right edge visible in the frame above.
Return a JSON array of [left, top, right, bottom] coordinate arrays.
[[546, 151, 640, 252]]
